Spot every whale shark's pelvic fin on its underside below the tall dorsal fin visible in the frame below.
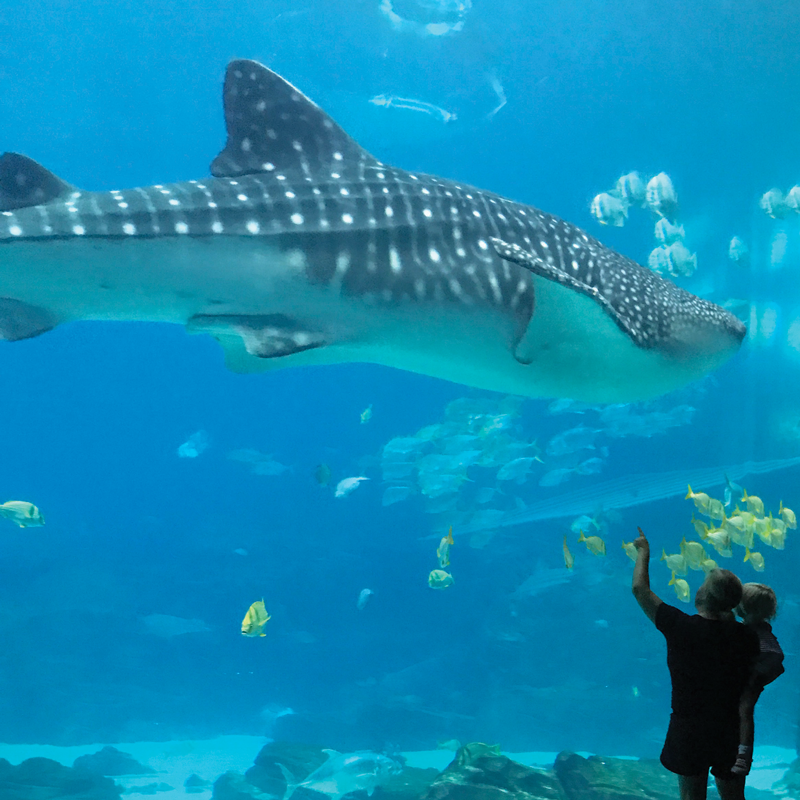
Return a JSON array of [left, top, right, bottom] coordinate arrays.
[[186, 314, 328, 372]]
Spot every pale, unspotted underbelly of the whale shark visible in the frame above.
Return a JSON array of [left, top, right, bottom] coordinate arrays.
[[0, 237, 727, 402]]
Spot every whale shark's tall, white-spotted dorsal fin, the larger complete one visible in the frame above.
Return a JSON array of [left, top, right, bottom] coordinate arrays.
[[211, 60, 378, 178]]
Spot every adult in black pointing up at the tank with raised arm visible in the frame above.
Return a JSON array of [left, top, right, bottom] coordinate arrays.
[[633, 529, 759, 800]]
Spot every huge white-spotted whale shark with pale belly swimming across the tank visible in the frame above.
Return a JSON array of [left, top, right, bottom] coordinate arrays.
[[0, 60, 745, 403]]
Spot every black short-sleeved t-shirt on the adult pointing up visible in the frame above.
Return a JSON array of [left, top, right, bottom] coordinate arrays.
[[656, 603, 759, 721]]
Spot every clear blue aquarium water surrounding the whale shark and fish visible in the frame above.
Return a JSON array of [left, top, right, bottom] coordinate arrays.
[[0, 0, 800, 755]]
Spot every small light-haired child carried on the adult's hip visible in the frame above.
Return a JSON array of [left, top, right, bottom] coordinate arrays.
[[731, 583, 784, 775]]
